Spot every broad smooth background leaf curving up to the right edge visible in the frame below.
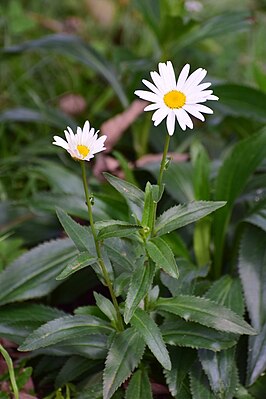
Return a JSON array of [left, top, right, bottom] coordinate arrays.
[[213, 129, 266, 277]]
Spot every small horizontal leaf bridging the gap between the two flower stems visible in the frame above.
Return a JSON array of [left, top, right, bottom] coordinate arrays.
[[95, 220, 142, 240]]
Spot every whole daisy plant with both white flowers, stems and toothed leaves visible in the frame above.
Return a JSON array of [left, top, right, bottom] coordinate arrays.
[[12, 62, 255, 399]]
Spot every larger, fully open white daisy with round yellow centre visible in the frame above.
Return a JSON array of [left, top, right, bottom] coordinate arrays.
[[135, 61, 219, 136]]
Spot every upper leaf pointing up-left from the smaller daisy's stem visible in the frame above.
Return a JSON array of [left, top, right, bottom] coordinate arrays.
[[56, 208, 95, 256]]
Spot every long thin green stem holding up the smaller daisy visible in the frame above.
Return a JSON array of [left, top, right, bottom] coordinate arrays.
[[80, 161, 124, 331]]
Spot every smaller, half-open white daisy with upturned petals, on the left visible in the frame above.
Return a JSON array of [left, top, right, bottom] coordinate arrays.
[[53, 121, 107, 161]]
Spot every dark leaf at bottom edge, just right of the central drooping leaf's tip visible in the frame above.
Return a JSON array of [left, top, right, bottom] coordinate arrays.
[[163, 347, 196, 399]]
